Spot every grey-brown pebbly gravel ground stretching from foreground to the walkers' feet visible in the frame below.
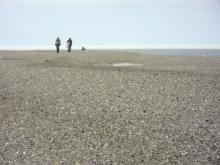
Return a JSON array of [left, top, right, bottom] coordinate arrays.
[[0, 51, 220, 165]]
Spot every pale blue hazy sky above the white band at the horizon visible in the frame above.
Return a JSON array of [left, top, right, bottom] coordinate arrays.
[[0, 0, 220, 46]]
